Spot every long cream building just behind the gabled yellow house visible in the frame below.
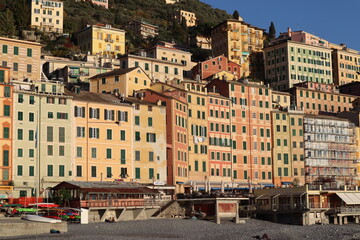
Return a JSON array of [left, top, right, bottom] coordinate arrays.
[[119, 54, 184, 83]]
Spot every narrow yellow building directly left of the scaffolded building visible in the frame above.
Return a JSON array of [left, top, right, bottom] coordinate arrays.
[[271, 107, 305, 186]]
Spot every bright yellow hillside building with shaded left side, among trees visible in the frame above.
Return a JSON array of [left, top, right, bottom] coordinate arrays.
[[75, 24, 125, 57]]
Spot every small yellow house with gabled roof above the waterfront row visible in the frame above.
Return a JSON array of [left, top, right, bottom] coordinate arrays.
[[90, 67, 151, 97]]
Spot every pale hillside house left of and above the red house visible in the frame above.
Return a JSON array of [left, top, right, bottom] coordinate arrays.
[[146, 41, 196, 71]]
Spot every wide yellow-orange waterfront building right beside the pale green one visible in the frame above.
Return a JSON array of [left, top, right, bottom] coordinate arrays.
[[67, 91, 135, 181]]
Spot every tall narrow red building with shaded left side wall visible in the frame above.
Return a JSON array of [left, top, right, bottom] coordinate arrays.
[[138, 83, 189, 192]]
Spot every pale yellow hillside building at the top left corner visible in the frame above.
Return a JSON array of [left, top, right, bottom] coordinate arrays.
[[31, 0, 64, 33]]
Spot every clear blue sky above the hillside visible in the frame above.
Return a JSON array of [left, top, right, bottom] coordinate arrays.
[[200, 0, 360, 51]]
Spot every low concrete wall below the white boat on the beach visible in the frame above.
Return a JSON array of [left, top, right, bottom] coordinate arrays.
[[0, 218, 68, 237]]
